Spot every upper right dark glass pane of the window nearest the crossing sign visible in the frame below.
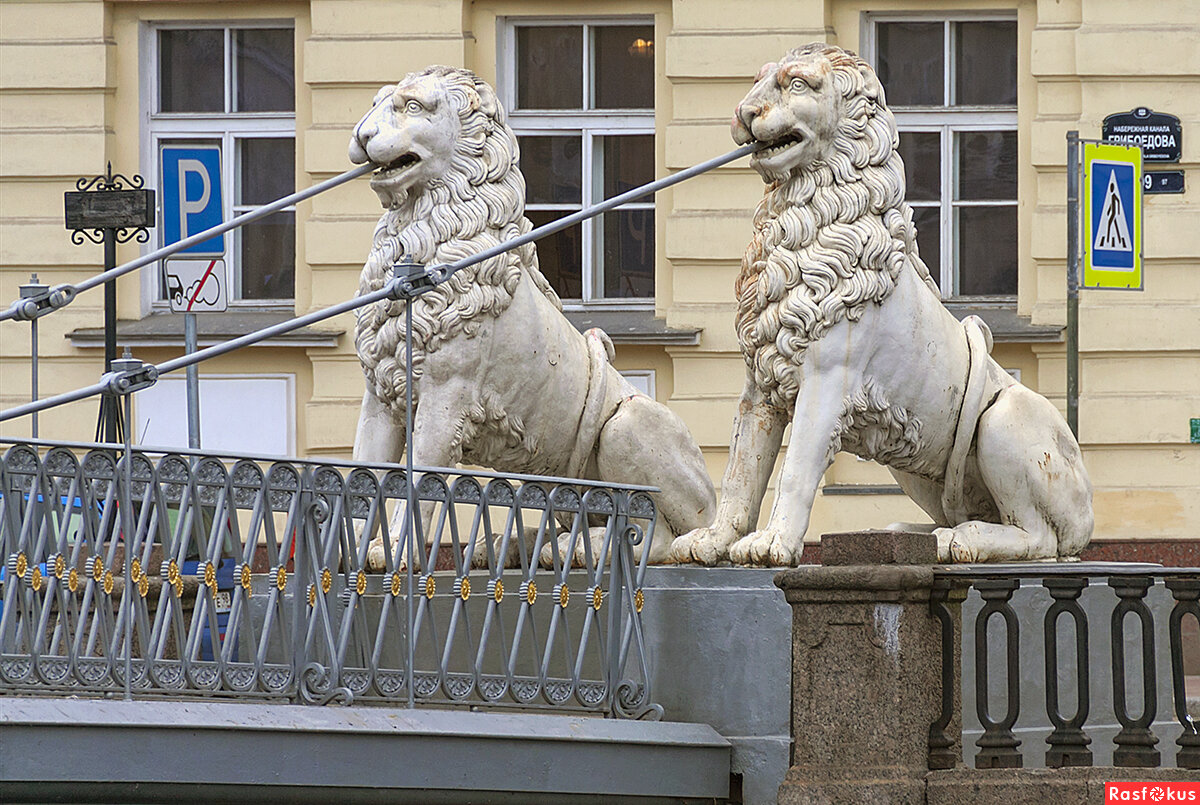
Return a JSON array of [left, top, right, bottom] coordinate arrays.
[[954, 22, 1016, 106]]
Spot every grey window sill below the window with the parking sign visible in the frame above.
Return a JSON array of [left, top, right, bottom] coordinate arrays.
[[67, 310, 346, 349]]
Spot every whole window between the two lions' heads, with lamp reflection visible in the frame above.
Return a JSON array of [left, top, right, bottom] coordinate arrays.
[[499, 20, 654, 306]]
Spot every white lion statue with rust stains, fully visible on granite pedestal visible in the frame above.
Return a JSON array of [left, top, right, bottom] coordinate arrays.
[[672, 44, 1093, 565]]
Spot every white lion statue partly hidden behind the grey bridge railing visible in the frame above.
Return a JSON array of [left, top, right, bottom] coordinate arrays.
[[349, 66, 716, 569]]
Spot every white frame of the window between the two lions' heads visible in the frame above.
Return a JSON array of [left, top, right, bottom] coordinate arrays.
[[496, 14, 658, 310]]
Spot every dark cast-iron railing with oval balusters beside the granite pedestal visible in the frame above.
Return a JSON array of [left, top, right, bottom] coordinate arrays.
[[929, 564, 1200, 769]]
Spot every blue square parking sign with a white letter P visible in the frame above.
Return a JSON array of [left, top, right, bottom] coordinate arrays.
[[162, 145, 226, 256]]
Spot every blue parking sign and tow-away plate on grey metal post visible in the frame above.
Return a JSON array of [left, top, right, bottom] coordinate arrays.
[[160, 145, 226, 450]]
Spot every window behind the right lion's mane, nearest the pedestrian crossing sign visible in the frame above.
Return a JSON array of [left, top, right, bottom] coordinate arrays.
[[865, 16, 1016, 296]]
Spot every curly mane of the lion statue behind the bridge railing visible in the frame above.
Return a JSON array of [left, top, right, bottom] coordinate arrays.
[[355, 65, 562, 407]]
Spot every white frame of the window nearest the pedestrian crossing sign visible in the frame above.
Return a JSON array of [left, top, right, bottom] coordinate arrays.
[[863, 10, 1021, 302]]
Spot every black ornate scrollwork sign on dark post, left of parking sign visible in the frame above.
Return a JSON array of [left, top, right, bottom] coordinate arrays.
[[62, 162, 154, 443]]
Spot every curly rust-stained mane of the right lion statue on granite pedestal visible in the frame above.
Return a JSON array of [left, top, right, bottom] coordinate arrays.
[[734, 44, 937, 411]]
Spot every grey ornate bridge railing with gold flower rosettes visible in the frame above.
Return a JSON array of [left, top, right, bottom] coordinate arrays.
[[0, 443, 661, 717]]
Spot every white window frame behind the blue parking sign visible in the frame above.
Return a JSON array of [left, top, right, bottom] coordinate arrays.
[[138, 18, 300, 313]]
